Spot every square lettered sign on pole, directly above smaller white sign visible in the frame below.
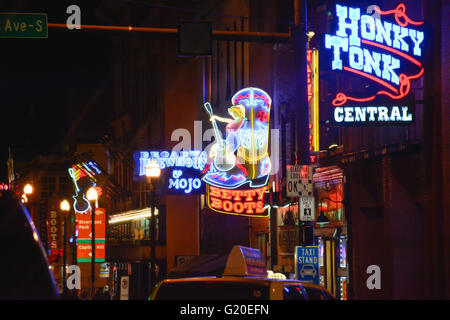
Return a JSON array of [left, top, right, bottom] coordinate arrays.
[[286, 165, 313, 197]]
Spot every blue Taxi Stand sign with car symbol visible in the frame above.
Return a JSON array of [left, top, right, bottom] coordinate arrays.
[[295, 246, 320, 284]]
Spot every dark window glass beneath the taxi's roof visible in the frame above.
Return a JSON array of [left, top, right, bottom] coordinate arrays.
[[155, 281, 269, 300]]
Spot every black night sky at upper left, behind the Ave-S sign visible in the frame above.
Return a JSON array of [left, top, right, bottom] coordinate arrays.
[[0, 1, 116, 181]]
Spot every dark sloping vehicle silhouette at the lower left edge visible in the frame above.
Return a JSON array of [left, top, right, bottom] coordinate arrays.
[[0, 190, 59, 300]]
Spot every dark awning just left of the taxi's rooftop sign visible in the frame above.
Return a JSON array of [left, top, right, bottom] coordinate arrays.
[[168, 254, 228, 279]]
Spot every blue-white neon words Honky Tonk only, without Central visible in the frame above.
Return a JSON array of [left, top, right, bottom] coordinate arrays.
[[325, 4, 424, 85]]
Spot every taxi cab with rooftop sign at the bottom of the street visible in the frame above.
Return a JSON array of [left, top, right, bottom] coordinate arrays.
[[150, 246, 335, 300]]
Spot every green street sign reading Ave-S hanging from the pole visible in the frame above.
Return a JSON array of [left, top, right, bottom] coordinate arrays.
[[0, 12, 48, 39]]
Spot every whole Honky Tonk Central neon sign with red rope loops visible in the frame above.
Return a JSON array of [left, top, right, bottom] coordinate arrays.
[[325, 4, 425, 123]]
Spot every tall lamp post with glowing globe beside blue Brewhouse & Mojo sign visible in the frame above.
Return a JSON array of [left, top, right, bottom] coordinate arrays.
[[145, 161, 161, 292]]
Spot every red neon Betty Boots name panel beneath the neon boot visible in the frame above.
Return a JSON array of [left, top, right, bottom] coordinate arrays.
[[207, 185, 267, 217]]
